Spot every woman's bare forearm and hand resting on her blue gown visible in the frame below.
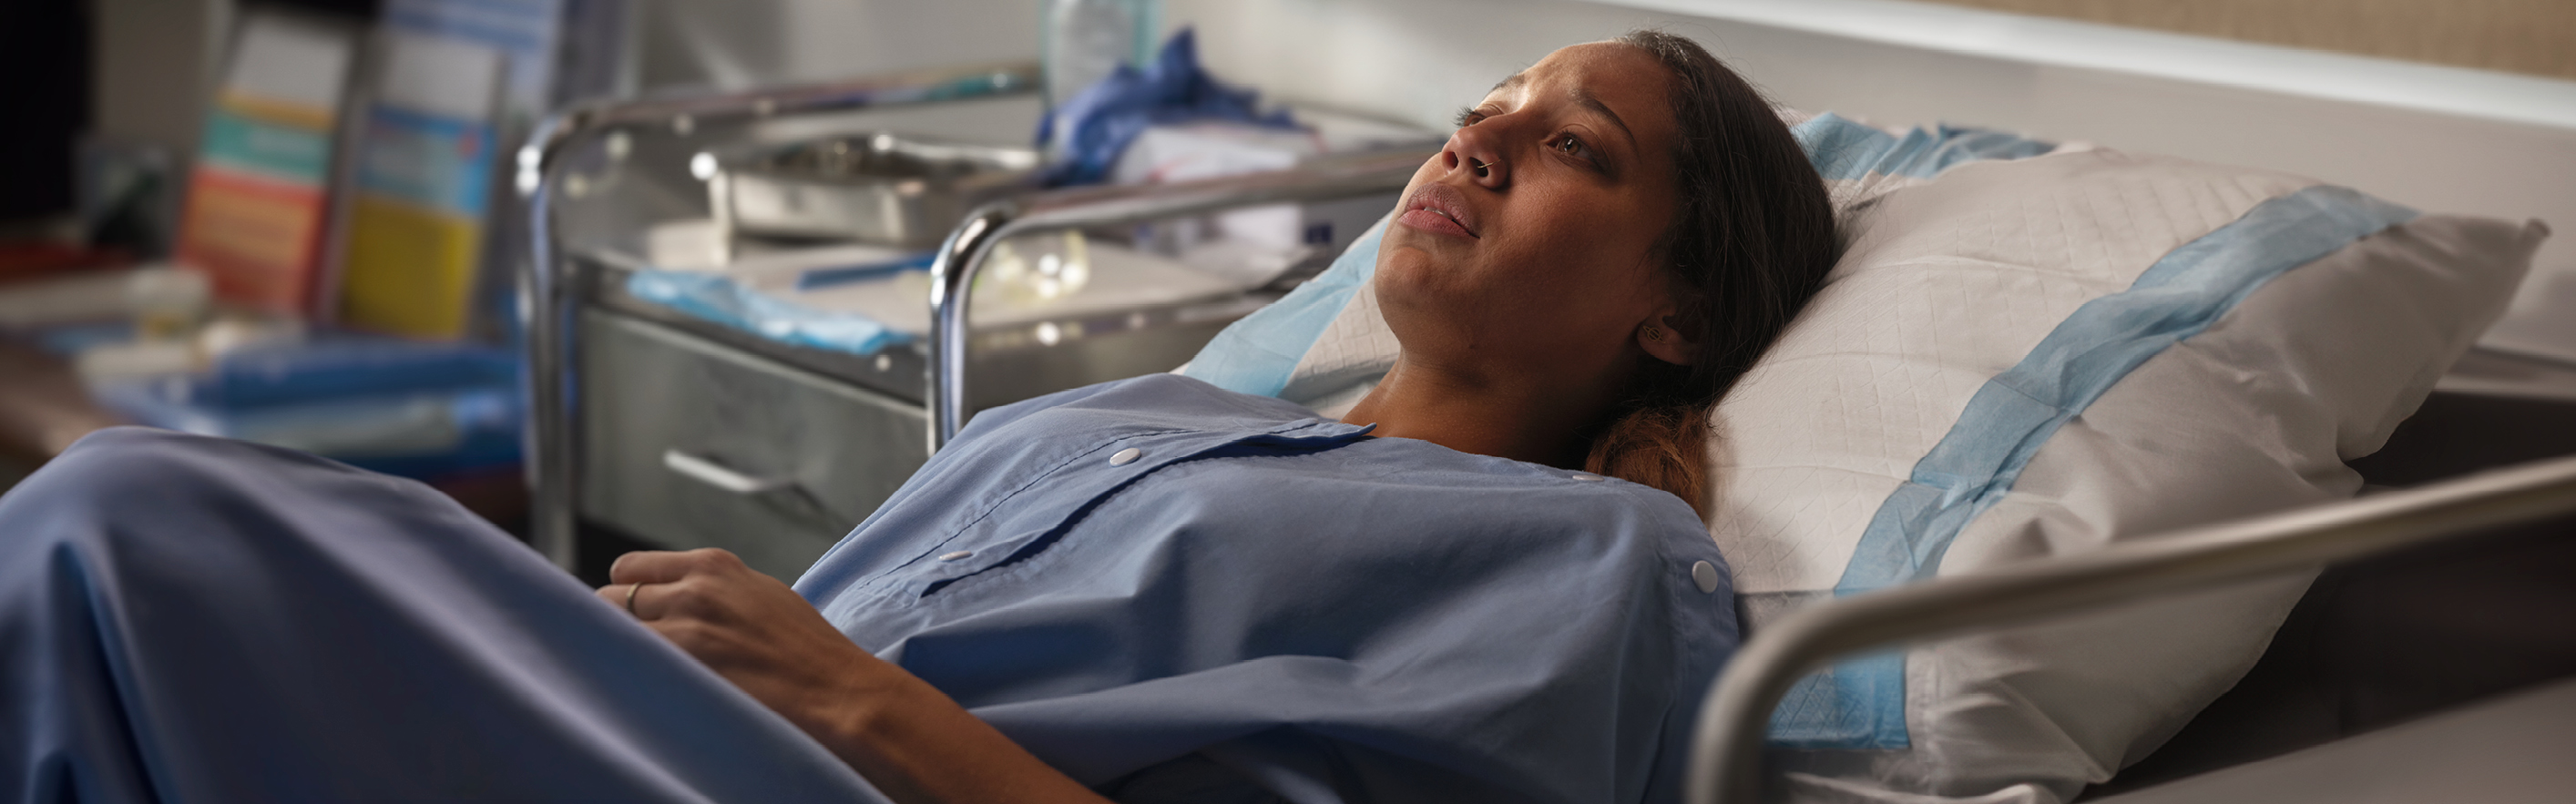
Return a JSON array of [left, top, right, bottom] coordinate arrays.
[[598, 549, 1108, 804]]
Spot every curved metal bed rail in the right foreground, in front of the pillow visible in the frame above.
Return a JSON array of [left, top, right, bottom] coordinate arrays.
[[1687, 456, 2576, 804]]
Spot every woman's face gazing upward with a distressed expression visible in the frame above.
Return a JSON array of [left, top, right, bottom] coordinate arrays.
[[1375, 41, 1680, 387]]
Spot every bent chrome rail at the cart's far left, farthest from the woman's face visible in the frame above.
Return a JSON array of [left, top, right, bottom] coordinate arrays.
[[513, 62, 1038, 569]]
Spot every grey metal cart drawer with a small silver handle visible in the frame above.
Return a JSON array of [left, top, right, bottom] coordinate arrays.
[[579, 310, 927, 580]]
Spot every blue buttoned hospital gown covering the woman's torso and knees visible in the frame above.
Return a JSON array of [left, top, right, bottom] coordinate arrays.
[[0, 376, 1736, 801]]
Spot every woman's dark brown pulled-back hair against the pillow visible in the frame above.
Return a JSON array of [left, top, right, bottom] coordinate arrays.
[[1584, 31, 1839, 515]]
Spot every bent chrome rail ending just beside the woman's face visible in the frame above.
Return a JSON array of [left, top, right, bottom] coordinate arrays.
[[925, 149, 1435, 453]]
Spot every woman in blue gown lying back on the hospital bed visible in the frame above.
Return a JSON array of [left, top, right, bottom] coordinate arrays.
[[0, 34, 1835, 801]]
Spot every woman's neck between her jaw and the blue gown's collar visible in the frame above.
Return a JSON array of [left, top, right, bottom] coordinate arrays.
[[1342, 358, 1605, 469]]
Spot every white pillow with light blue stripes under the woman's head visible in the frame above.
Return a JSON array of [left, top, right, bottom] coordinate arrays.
[[1188, 116, 2548, 801]]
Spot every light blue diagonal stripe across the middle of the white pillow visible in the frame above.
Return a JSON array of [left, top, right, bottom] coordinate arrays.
[[1770, 186, 2417, 748]]
